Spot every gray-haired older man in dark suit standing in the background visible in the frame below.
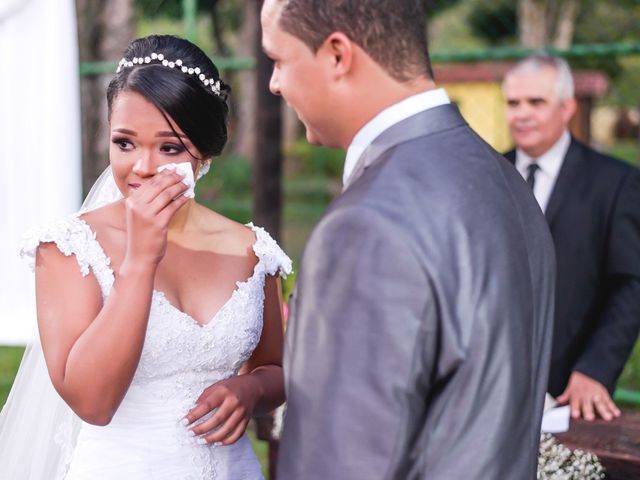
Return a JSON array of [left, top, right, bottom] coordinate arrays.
[[503, 55, 640, 420]]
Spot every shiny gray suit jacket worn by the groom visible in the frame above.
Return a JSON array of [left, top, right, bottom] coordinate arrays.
[[278, 105, 555, 480]]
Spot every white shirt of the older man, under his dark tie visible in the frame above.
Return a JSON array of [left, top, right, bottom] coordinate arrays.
[[516, 130, 571, 212]]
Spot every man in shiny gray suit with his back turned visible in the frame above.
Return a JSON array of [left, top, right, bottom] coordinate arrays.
[[261, 0, 554, 480]]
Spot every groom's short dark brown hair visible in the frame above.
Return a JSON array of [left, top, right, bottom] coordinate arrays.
[[279, 0, 433, 82]]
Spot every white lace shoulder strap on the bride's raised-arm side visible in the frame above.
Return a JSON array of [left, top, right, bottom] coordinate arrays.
[[20, 214, 114, 295]]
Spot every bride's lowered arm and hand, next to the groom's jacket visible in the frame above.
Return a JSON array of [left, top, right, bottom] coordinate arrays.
[[185, 276, 284, 445]]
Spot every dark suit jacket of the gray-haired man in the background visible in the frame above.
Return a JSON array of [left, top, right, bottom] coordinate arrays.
[[506, 139, 640, 396]]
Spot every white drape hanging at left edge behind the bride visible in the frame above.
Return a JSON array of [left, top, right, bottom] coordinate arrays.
[[0, 0, 81, 345]]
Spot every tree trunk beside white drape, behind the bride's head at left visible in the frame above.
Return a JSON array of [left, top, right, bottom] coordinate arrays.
[[76, 0, 134, 194]]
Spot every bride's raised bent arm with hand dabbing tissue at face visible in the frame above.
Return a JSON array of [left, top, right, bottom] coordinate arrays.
[[36, 174, 186, 425]]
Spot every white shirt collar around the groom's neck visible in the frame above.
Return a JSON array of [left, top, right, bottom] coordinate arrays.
[[342, 88, 451, 185]]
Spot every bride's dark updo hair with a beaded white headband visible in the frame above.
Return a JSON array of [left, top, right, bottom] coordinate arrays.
[[107, 35, 230, 159]]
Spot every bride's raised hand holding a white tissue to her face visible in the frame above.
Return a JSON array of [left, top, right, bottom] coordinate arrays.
[[125, 170, 189, 264]]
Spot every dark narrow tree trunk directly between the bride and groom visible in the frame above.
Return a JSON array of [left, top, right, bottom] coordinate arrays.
[[252, 2, 282, 240]]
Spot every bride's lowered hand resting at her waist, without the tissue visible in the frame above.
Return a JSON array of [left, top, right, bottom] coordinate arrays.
[[184, 374, 260, 445]]
